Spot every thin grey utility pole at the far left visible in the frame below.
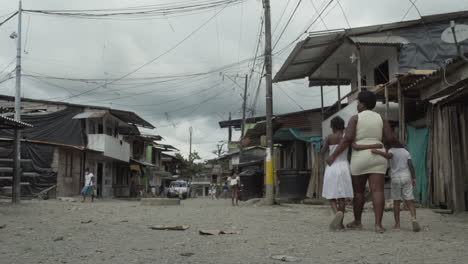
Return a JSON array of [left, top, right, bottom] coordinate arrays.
[[11, 0, 22, 203]]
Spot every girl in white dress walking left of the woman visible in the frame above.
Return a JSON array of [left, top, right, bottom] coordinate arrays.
[[321, 116, 353, 231]]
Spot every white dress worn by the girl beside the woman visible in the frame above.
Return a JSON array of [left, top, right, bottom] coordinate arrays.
[[322, 145, 353, 200]]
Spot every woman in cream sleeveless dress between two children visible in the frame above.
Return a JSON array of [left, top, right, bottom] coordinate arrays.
[[327, 91, 394, 233]]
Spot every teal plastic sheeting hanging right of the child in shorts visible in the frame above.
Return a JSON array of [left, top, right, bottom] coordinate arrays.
[[406, 126, 429, 204]]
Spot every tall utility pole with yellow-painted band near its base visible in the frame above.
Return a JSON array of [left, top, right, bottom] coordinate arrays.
[[263, 0, 274, 205]]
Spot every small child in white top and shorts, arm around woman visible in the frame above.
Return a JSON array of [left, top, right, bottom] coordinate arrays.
[[372, 139, 421, 232]]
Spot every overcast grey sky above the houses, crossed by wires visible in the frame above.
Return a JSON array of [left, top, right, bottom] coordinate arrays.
[[0, 0, 468, 159]]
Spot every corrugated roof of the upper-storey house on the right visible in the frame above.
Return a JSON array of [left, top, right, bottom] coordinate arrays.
[[273, 11, 468, 85]]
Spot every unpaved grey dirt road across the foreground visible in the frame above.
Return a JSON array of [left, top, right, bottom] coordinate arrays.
[[0, 199, 468, 264]]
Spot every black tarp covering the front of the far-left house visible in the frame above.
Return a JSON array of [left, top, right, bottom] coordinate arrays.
[[0, 107, 85, 196]]
